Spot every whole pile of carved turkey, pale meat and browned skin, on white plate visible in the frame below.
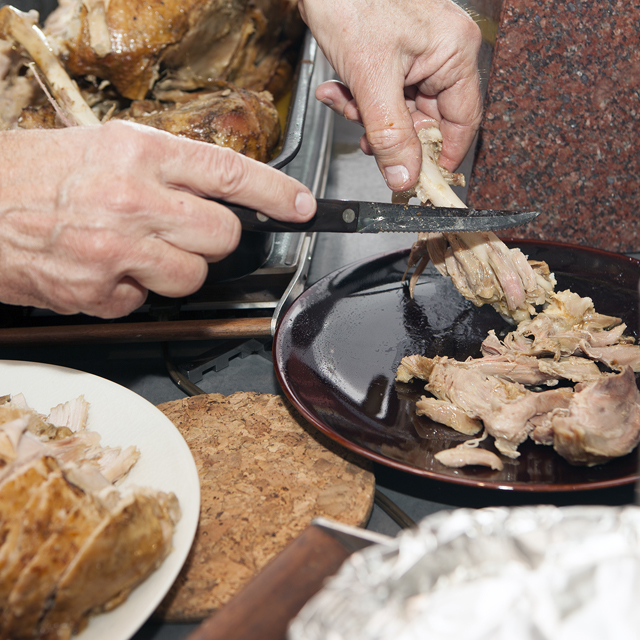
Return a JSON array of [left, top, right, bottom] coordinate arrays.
[[0, 395, 180, 640]]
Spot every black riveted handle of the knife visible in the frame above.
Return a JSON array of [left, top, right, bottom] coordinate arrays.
[[220, 198, 360, 233]]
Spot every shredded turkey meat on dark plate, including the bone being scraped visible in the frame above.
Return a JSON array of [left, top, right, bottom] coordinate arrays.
[[396, 129, 640, 470]]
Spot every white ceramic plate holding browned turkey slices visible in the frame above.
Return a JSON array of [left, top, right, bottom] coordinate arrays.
[[0, 360, 200, 640]]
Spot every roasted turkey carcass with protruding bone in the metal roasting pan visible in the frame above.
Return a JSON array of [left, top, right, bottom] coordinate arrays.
[[0, 0, 302, 162]]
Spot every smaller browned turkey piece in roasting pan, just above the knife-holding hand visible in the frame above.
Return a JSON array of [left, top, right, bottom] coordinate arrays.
[[121, 83, 280, 162]]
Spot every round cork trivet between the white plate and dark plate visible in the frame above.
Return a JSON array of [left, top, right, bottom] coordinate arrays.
[[155, 393, 375, 622]]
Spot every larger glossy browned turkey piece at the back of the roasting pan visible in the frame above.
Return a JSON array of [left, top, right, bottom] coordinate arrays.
[[46, 0, 302, 100]]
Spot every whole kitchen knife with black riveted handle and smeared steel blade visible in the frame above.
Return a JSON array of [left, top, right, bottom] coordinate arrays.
[[221, 198, 540, 233]]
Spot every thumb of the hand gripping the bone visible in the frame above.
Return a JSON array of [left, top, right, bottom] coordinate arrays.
[[353, 81, 422, 191]]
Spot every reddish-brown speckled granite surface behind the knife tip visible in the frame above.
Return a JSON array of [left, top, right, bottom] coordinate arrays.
[[467, 0, 640, 252]]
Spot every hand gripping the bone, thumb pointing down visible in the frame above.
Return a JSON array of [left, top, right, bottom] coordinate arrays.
[[298, 0, 482, 191]]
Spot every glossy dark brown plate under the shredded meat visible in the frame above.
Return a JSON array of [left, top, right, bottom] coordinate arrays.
[[273, 240, 640, 491]]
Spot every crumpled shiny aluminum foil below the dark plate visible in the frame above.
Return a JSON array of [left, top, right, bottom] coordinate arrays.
[[289, 506, 640, 640]]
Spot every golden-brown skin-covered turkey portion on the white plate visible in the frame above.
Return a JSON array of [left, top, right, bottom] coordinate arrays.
[[0, 470, 179, 640]]
